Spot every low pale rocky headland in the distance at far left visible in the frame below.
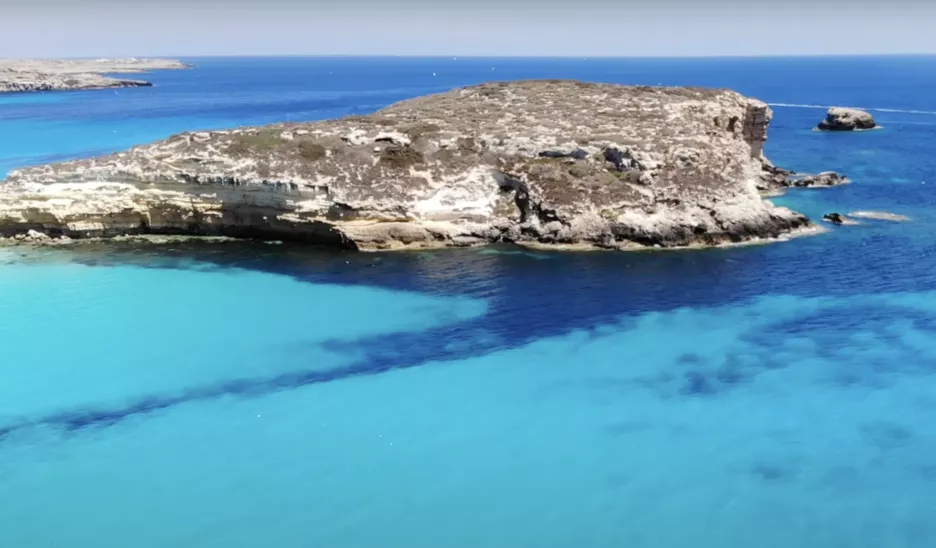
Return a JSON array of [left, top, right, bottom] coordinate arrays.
[[0, 58, 189, 93]]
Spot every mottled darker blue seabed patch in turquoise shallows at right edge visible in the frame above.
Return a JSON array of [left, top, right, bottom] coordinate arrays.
[[631, 296, 936, 398]]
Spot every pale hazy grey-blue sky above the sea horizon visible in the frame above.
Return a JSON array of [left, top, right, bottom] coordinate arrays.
[[0, 0, 936, 57]]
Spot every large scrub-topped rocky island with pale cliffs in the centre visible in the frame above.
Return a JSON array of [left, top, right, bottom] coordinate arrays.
[[0, 80, 840, 250]]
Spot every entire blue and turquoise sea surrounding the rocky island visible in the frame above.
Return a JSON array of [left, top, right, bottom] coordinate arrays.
[[0, 57, 936, 548]]
